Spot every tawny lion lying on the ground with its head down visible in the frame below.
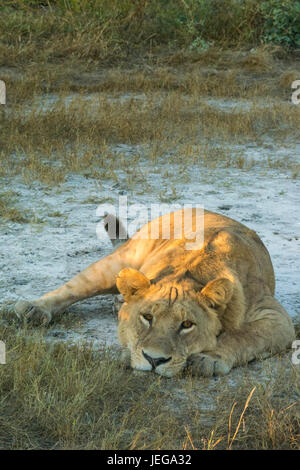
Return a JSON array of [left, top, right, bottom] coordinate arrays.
[[15, 209, 295, 377]]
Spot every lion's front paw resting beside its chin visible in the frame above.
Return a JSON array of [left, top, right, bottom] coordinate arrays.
[[188, 353, 231, 377]]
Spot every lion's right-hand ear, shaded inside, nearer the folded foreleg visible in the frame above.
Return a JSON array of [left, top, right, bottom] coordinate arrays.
[[200, 278, 233, 308]]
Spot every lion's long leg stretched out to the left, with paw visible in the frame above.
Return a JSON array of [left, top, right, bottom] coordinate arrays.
[[15, 246, 130, 323]]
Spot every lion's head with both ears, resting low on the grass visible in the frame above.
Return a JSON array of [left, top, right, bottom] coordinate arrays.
[[117, 268, 233, 377]]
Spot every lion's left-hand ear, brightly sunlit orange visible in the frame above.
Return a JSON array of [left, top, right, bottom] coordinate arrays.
[[116, 268, 150, 302]]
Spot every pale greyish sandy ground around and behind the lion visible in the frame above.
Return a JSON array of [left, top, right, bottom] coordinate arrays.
[[0, 163, 300, 328]]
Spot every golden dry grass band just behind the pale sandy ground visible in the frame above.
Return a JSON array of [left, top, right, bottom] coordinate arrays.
[[0, 85, 300, 185]]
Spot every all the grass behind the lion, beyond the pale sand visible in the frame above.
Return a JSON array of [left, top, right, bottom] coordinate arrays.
[[0, 0, 300, 189]]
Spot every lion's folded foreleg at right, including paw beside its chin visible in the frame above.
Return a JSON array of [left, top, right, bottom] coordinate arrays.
[[189, 296, 295, 377]]
